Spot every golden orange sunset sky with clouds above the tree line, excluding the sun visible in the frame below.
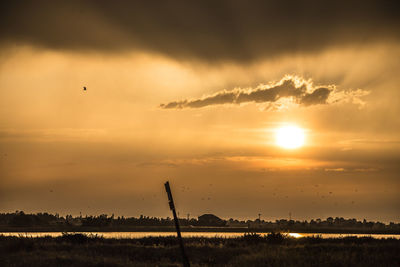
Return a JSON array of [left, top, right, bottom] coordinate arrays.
[[0, 0, 400, 222]]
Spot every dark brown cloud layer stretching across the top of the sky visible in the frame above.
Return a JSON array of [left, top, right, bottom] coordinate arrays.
[[0, 0, 400, 61]]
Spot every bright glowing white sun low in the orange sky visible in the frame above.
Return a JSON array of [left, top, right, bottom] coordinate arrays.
[[275, 125, 305, 149]]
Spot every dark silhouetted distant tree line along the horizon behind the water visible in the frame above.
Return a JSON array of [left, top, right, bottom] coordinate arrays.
[[0, 211, 400, 231]]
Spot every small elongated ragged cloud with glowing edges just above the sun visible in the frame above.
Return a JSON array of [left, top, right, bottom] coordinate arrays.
[[160, 75, 368, 109]]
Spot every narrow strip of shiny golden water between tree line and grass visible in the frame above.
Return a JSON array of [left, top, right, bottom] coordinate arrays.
[[0, 232, 400, 239]]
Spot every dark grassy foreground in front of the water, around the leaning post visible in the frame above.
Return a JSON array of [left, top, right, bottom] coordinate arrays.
[[0, 234, 400, 267]]
